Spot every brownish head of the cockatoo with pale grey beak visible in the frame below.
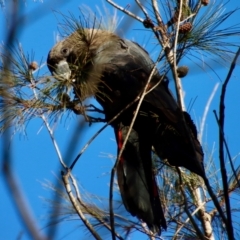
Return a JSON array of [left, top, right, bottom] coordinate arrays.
[[47, 28, 117, 100]]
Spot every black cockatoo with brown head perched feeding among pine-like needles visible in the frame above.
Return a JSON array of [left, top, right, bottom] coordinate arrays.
[[47, 29, 205, 233]]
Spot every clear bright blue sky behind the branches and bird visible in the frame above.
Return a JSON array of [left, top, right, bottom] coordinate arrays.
[[0, 0, 240, 240]]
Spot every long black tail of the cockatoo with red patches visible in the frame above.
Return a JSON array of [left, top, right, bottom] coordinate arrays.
[[115, 124, 167, 234]]
